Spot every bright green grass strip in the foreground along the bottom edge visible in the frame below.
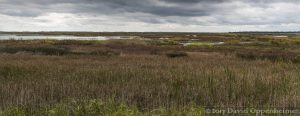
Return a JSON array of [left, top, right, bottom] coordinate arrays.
[[0, 99, 205, 116]]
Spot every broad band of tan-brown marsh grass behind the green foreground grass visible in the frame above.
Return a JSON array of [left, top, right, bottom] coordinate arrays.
[[0, 54, 300, 113]]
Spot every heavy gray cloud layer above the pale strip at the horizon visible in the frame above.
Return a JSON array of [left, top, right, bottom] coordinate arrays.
[[0, 0, 300, 29]]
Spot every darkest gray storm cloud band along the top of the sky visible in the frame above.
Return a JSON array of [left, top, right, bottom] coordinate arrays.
[[0, 0, 297, 16]]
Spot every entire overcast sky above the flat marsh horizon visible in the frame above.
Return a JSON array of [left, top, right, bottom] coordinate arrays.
[[0, 0, 300, 32]]
